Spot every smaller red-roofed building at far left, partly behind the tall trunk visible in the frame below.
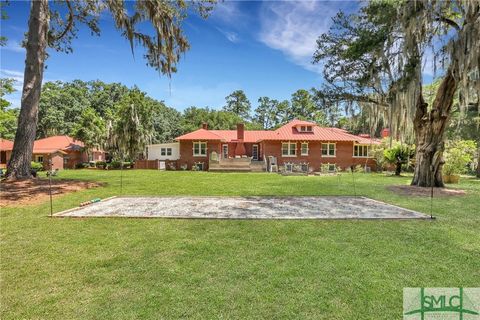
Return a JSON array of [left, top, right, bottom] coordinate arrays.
[[1, 136, 105, 169]]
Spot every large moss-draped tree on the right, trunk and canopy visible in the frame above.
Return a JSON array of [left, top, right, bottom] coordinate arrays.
[[314, 0, 480, 187]]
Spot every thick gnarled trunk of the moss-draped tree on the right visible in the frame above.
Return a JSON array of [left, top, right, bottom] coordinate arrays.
[[412, 68, 458, 187]]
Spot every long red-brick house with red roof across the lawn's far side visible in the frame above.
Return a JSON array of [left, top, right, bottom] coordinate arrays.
[[175, 120, 379, 171]]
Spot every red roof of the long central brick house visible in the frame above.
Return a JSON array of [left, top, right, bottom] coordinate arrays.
[[176, 120, 378, 144]]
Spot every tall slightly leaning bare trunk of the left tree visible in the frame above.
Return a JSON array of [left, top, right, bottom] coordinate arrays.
[[7, 0, 49, 180]]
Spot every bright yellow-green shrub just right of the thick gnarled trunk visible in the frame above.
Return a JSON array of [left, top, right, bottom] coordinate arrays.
[[443, 140, 476, 175]]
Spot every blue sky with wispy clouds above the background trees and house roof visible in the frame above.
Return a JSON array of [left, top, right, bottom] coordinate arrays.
[[0, 1, 358, 111]]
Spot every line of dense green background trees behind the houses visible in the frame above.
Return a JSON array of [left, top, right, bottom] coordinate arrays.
[[0, 79, 474, 162]]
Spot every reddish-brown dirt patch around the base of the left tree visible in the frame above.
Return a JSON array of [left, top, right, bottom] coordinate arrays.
[[0, 179, 102, 207]]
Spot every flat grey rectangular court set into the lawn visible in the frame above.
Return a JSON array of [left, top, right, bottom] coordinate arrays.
[[54, 196, 429, 219]]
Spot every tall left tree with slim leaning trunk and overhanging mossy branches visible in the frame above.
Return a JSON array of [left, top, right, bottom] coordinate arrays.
[[7, 0, 215, 179]]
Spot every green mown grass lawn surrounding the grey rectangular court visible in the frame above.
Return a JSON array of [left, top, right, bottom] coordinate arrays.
[[0, 170, 480, 319]]
